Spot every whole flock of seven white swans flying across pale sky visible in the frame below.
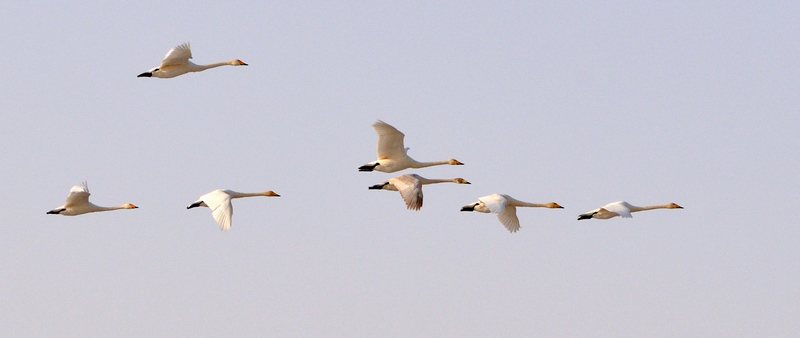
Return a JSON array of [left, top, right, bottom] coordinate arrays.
[[47, 42, 683, 233]]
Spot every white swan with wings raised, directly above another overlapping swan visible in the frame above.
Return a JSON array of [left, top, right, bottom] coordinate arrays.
[[358, 120, 464, 173]]
